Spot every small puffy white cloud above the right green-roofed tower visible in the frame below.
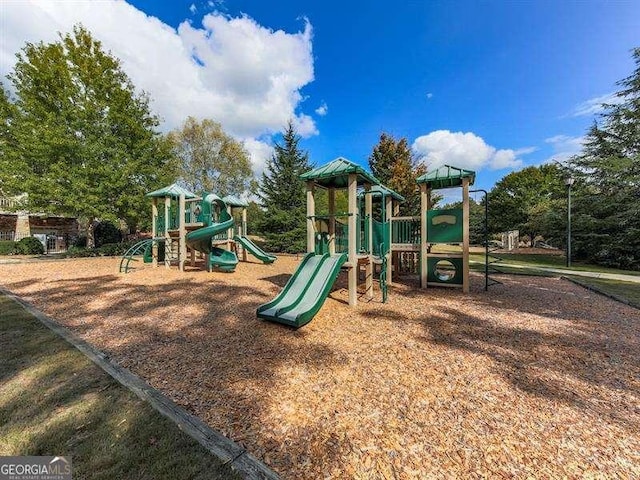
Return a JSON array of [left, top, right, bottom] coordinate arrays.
[[412, 130, 536, 170]]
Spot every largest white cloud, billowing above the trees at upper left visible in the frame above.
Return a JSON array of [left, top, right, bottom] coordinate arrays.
[[0, 0, 318, 152]]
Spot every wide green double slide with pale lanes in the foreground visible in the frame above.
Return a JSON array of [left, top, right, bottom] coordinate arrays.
[[256, 253, 347, 328]]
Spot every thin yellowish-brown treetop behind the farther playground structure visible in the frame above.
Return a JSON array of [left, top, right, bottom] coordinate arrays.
[[169, 117, 253, 197]]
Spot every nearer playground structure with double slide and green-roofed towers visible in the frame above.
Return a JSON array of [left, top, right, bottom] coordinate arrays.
[[256, 158, 475, 328]]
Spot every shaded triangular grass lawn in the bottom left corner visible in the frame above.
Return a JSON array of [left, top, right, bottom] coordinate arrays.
[[0, 295, 237, 480]]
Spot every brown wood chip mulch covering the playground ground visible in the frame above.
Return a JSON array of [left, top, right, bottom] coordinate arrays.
[[0, 256, 640, 479]]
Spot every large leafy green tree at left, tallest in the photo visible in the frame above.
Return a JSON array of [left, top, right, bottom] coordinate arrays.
[[0, 26, 174, 246]]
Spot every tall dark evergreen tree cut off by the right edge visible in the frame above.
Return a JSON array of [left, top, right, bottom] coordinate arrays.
[[570, 48, 640, 269]]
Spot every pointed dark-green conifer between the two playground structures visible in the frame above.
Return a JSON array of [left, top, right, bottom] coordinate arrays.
[[260, 121, 310, 253]]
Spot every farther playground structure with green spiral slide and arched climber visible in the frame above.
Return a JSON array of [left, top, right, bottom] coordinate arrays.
[[120, 184, 276, 273]]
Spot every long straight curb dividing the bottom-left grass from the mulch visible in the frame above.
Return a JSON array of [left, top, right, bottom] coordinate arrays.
[[0, 286, 280, 480]]
